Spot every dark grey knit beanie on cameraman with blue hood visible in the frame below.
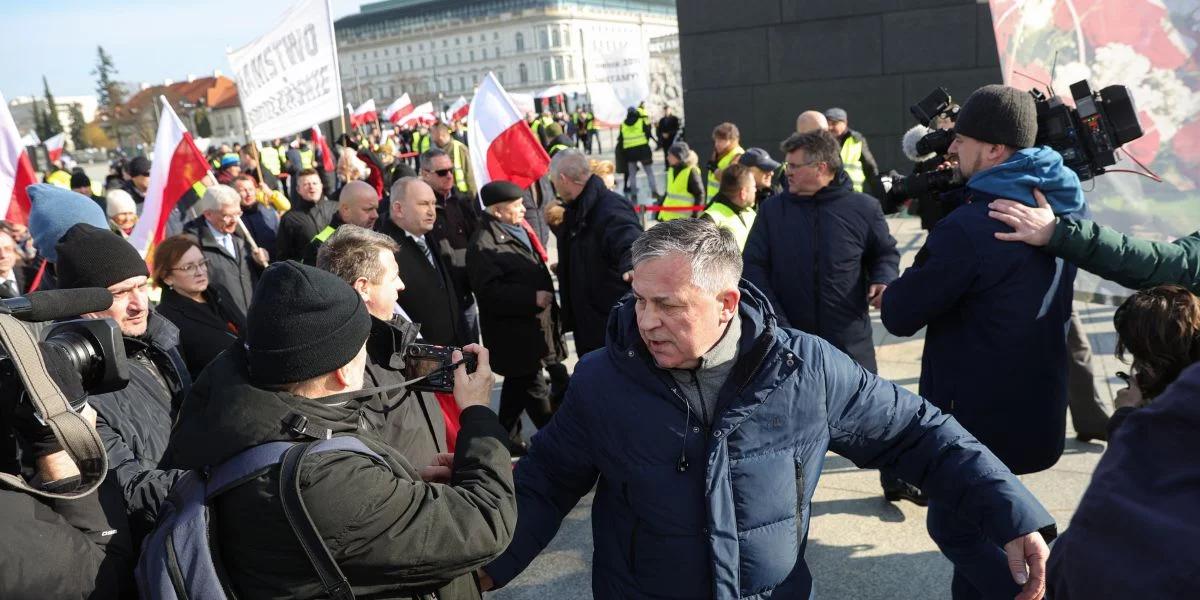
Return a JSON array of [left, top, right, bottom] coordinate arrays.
[[954, 85, 1038, 149]]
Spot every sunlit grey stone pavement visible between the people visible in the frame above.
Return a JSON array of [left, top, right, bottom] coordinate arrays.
[[487, 213, 1123, 600]]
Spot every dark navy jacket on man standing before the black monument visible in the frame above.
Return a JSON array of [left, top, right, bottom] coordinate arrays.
[[743, 172, 900, 372]]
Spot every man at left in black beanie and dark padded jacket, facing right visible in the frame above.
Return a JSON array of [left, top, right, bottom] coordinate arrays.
[[55, 223, 192, 544]]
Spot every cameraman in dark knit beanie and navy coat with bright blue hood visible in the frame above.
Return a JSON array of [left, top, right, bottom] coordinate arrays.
[[882, 85, 1085, 599]]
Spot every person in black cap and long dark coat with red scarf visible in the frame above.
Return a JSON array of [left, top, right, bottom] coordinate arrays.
[[467, 181, 566, 452]]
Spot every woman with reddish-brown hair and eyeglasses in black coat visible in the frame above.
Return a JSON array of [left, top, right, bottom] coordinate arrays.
[[154, 235, 246, 379]]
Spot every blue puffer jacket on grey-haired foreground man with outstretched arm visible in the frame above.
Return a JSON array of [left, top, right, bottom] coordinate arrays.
[[485, 283, 1054, 599]]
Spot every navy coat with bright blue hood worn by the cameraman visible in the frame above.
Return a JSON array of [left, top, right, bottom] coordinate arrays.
[[882, 149, 1085, 473]]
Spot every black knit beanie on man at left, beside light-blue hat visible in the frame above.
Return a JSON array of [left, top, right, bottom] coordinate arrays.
[[54, 223, 150, 289]]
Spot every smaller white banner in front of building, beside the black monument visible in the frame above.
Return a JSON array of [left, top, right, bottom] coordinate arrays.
[[587, 38, 650, 125]]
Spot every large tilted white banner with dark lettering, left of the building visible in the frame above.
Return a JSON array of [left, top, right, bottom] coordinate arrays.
[[228, 0, 342, 139]]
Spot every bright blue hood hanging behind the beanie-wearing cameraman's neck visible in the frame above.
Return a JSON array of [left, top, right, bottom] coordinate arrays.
[[967, 146, 1087, 216]]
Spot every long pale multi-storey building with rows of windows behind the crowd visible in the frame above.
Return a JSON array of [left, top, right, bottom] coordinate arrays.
[[335, 0, 678, 109]]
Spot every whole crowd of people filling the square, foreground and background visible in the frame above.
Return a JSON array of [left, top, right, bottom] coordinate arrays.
[[0, 85, 1200, 600]]
